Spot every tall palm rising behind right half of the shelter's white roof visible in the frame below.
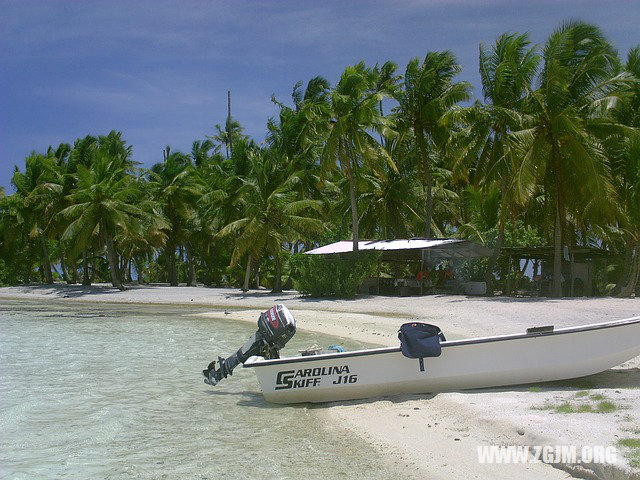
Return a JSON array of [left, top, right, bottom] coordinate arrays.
[[396, 50, 471, 238]]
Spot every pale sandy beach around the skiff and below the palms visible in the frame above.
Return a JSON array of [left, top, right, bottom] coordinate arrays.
[[0, 284, 640, 479]]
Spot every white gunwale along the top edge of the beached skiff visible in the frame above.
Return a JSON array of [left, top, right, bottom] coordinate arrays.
[[242, 316, 640, 368]]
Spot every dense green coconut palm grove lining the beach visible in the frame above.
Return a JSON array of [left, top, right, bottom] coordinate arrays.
[[0, 22, 640, 296]]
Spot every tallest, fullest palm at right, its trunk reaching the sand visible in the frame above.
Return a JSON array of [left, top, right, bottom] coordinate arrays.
[[513, 22, 631, 296]]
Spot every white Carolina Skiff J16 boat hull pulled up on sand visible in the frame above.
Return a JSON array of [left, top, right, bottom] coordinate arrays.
[[242, 317, 640, 403]]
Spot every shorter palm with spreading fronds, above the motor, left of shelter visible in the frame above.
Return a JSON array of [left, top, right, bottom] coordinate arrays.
[[219, 151, 322, 292]]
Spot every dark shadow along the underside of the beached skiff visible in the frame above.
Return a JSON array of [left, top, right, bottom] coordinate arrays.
[[221, 368, 640, 408]]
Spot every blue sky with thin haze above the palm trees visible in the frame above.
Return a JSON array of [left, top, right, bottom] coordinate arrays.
[[0, 0, 640, 193]]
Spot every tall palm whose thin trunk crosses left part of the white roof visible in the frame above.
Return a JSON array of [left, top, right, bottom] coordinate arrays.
[[323, 62, 395, 253]]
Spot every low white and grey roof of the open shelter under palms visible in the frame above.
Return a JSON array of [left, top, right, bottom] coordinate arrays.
[[306, 238, 492, 260]]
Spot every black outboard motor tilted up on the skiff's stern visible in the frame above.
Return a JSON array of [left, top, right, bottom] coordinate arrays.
[[202, 304, 296, 386]]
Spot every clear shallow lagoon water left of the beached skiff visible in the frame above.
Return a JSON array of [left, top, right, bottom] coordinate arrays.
[[0, 302, 394, 479]]
